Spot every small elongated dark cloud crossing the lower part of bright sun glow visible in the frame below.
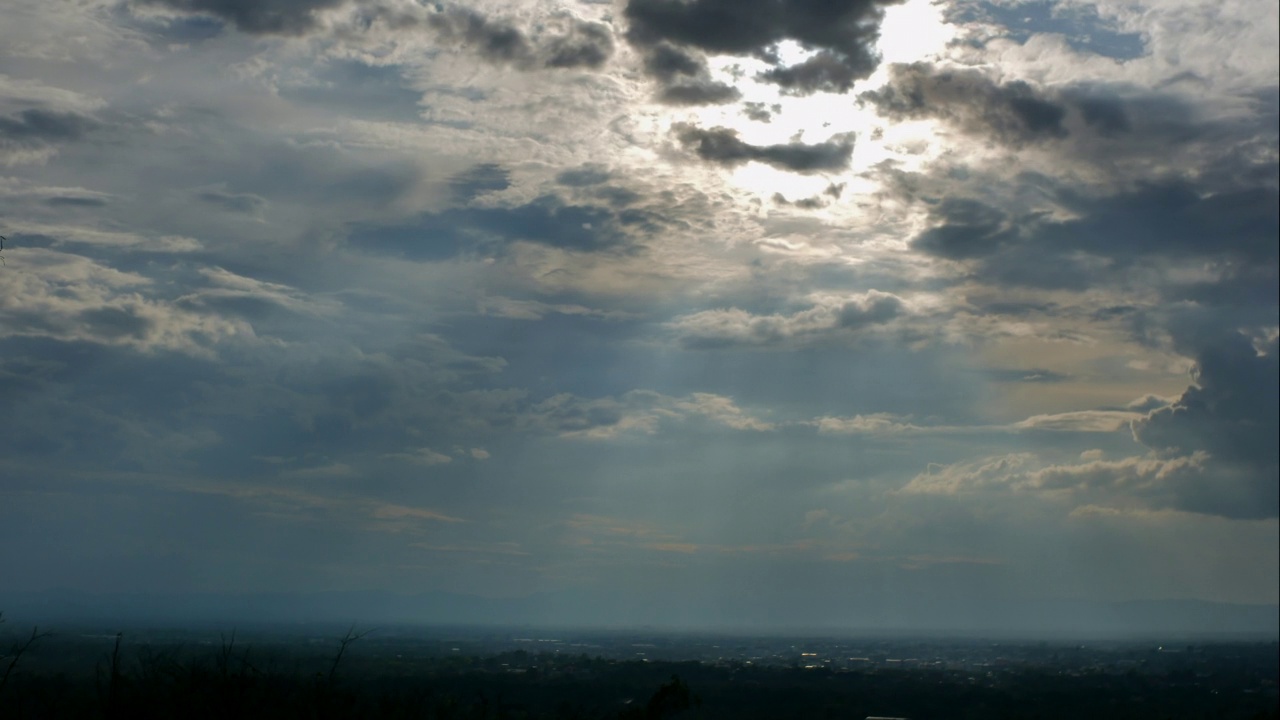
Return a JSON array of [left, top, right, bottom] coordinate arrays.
[[672, 123, 854, 173]]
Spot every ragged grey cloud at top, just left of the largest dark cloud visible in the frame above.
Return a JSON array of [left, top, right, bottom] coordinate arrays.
[[426, 8, 614, 69]]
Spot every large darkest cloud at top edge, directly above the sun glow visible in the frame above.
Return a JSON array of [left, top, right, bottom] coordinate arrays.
[[625, 0, 893, 95]]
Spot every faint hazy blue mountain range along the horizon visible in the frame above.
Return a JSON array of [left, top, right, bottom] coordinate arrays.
[[0, 589, 1280, 638]]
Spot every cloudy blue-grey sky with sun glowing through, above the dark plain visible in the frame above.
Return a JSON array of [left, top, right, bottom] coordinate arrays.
[[0, 0, 1280, 626]]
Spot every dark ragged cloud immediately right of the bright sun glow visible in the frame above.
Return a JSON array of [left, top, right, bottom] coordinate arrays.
[[859, 63, 1070, 143]]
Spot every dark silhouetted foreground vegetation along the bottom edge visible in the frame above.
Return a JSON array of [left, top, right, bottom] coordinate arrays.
[[0, 614, 1280, 720]]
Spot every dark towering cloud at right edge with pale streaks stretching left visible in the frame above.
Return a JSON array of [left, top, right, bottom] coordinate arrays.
[[901, 351, 1280, 519]]
